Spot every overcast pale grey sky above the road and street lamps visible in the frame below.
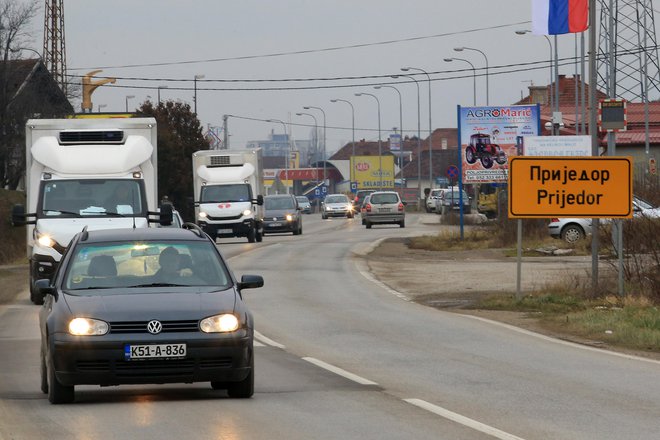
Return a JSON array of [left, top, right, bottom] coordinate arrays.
[[21, 0, 636, 152]]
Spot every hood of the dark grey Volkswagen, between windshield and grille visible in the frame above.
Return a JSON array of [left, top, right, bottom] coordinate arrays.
[[63, 288, 238, 321]]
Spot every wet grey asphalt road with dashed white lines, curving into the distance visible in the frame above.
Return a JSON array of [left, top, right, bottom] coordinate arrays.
[[0, 214, 660, 440]]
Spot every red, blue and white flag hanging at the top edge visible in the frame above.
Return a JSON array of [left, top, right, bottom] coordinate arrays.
[[532, 0, 589, 35]]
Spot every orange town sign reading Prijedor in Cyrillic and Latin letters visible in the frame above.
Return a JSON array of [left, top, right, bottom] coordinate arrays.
[[509, 157, 632, 218]]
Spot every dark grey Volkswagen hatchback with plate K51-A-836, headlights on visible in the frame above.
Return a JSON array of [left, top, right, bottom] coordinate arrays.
[[36, 223, 263, 403]]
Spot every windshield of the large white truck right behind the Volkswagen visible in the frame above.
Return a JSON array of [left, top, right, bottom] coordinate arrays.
[[40, 179, 146, 217]]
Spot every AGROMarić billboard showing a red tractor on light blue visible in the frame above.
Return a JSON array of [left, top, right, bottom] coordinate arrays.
[[458, 104, 540, 184]]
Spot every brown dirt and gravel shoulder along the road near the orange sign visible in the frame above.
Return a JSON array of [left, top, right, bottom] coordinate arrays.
[[363, 238, 660, 360]]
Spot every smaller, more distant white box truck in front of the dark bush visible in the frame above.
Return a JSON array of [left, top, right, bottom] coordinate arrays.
[[192, 148, 264, 243]]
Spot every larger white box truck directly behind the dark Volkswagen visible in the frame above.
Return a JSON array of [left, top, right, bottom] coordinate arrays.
[[12, 118, 171, 304]]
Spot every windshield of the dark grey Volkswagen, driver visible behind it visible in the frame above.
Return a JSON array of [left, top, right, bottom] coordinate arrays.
[[63, 241, 231, 295]]
